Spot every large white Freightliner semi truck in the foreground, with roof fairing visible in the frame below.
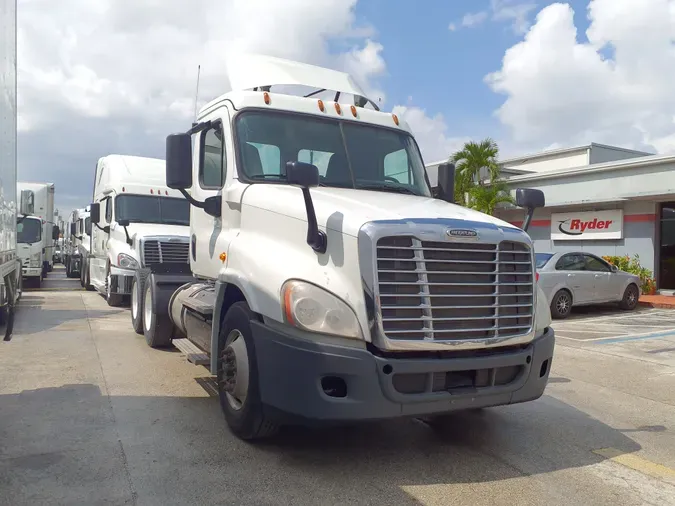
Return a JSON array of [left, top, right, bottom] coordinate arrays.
[[140, 55, 554, 439]]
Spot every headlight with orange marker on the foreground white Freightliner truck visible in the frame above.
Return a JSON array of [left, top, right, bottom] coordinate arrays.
[[281, 281, 361, 339]]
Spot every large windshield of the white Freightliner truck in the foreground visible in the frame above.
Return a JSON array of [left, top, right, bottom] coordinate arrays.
[[235, 111, 431, 197]]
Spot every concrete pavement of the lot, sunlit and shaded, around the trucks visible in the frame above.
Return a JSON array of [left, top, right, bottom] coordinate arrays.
[[0, 270, 675, 506]]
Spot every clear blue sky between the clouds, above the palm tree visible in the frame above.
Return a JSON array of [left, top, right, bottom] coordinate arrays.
[[356, 0, 589, 146]]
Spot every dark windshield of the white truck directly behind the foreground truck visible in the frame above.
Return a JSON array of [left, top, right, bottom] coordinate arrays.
[[115, 195, 190, 225]]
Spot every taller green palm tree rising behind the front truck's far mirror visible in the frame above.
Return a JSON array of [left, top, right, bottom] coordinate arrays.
[[450, 137, 500, 202]]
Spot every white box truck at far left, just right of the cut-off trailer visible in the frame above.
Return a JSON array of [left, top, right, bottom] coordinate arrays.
[[18, 182, 59, 285]]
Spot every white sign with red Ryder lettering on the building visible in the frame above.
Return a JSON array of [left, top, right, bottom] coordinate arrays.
[[551, 209, 623, 241]]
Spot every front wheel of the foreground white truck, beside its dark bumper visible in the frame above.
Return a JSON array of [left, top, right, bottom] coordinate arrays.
[[217, 302, 278, 440]]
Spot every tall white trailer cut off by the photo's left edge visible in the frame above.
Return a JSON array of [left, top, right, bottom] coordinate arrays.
[[0, 0, 21, 341]]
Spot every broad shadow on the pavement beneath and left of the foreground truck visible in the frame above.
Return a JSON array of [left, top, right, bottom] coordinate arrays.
[[0, 384, 640, 506]]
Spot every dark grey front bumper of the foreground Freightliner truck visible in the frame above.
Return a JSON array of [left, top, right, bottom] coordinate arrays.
[[251, 322, 555, 422]]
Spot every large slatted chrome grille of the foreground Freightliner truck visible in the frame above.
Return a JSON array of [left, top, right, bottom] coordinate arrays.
[[376, 236, 534, 341]]
